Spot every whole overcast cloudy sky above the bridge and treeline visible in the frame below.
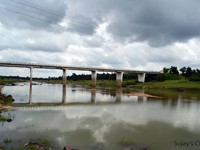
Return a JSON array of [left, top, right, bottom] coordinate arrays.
[[0, 0, 200, 76]]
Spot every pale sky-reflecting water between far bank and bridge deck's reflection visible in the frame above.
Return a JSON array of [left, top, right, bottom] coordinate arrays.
[[2, 83, 126, 104]]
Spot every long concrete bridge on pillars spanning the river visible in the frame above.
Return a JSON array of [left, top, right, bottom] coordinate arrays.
[[0, 61, 160, 87]]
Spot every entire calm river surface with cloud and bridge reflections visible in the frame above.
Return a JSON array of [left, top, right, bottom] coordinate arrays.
[[0, 83, 200, 150]]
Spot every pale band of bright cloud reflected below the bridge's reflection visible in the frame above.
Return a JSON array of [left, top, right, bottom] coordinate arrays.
[[10, 101, 200, 134]]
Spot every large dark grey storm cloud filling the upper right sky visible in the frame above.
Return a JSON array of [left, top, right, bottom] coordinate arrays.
[[68, 0, 200, 47]]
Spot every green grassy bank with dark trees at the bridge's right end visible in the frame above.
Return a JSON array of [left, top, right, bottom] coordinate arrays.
[[64, 66, 200, 90]]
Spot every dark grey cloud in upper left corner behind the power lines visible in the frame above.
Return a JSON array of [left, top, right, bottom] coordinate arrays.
[[0, 0, 67, 30]]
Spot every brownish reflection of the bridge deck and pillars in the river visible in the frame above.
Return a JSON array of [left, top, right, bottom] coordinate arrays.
[[13, 85, 147, 108]]
